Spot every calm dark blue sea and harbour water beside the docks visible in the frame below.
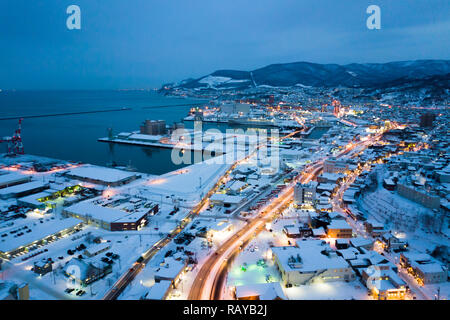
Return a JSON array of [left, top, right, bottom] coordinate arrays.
[[0, 91, 207, 174]]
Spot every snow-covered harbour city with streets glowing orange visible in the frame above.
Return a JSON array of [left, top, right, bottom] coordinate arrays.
[[0, 89, 450, 300]]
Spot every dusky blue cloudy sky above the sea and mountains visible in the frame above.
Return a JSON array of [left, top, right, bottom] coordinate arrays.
[[0, 0, 450, 89]]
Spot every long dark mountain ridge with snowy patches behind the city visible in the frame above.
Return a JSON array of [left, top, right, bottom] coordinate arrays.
[[165, 60, 450, 89]]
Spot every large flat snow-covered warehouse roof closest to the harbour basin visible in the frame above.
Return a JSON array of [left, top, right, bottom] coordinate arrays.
[[66, 165, 137, 185]]
